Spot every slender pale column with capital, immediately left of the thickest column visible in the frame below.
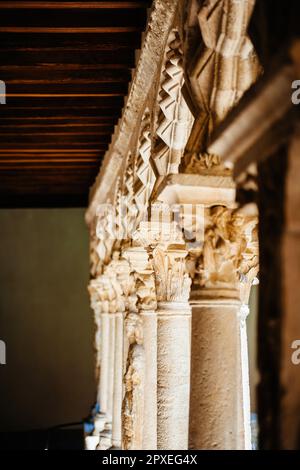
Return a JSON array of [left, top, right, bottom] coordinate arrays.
[[135, 222, 191, 450]]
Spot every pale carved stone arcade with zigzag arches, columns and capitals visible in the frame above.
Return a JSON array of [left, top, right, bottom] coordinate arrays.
[[86, 0, 299, 450]]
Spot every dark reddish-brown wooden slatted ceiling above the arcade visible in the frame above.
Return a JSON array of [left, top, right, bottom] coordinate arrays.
[[0, 0, 151, 207]]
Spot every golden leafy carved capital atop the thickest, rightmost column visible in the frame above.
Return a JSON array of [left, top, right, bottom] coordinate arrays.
[[188, 206, 258, 304]]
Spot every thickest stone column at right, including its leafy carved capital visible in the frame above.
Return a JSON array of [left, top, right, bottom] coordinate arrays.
[[189, 206, 258, 450]]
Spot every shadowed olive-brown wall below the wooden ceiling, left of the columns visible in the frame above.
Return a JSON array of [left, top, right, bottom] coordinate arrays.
[[0, 209, 95, 431]]
